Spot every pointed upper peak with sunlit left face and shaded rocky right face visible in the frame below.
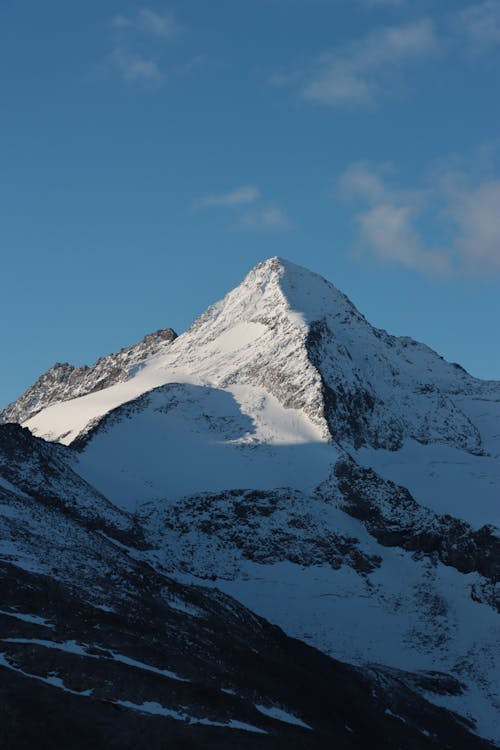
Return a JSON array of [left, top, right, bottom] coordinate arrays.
[[3, 258, 492, 453]]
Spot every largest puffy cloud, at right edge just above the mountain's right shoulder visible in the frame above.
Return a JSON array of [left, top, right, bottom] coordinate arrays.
[[339, 163, 500, 275]]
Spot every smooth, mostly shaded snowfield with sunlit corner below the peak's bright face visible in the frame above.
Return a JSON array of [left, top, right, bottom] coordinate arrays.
[[73, 383, 337, 510]]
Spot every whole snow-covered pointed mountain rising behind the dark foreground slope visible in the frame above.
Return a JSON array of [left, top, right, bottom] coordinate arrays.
[[0, 258, 500, 747]]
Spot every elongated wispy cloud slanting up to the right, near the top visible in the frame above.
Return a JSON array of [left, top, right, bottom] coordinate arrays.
[[270, 18, 440, 107]]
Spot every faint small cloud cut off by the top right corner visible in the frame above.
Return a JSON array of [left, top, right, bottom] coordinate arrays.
[[453, 0, 500, 53]]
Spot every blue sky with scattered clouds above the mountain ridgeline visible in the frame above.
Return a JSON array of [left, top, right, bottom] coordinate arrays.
[[0, 0, 500, 404]]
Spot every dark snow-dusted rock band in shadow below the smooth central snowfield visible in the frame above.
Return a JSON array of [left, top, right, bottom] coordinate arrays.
[[140, 488, 381, 578]]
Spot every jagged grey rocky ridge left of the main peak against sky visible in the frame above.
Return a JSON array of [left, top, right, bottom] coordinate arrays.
[[0, 328, 177, 423]]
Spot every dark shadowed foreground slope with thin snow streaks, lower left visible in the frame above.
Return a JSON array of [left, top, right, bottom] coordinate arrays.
[[0, 425, 491, 750]]
